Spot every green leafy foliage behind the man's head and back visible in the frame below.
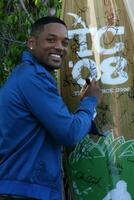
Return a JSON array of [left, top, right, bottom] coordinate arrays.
[[0, 0, 62, 85]]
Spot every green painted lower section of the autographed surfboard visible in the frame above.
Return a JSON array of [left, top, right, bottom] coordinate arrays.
[[69, 131, 134, 200]]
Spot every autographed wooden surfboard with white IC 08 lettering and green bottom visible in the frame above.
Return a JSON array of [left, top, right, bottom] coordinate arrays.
[[60, 0, 134, 200]]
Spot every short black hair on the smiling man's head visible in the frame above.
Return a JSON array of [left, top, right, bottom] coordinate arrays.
[[30, 16, 67, 36]]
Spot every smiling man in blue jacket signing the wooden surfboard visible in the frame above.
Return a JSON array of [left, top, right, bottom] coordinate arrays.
[[0, 17, 101, 200]]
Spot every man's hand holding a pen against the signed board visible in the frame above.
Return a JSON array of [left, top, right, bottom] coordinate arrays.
[[80, 79, 102, 104]]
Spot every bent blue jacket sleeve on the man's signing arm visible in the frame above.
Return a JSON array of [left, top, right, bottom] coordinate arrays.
[[18, 71, 97, 146]]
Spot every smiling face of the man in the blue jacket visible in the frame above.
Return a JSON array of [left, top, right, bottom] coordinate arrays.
[[29, 23, 68, 69]]
